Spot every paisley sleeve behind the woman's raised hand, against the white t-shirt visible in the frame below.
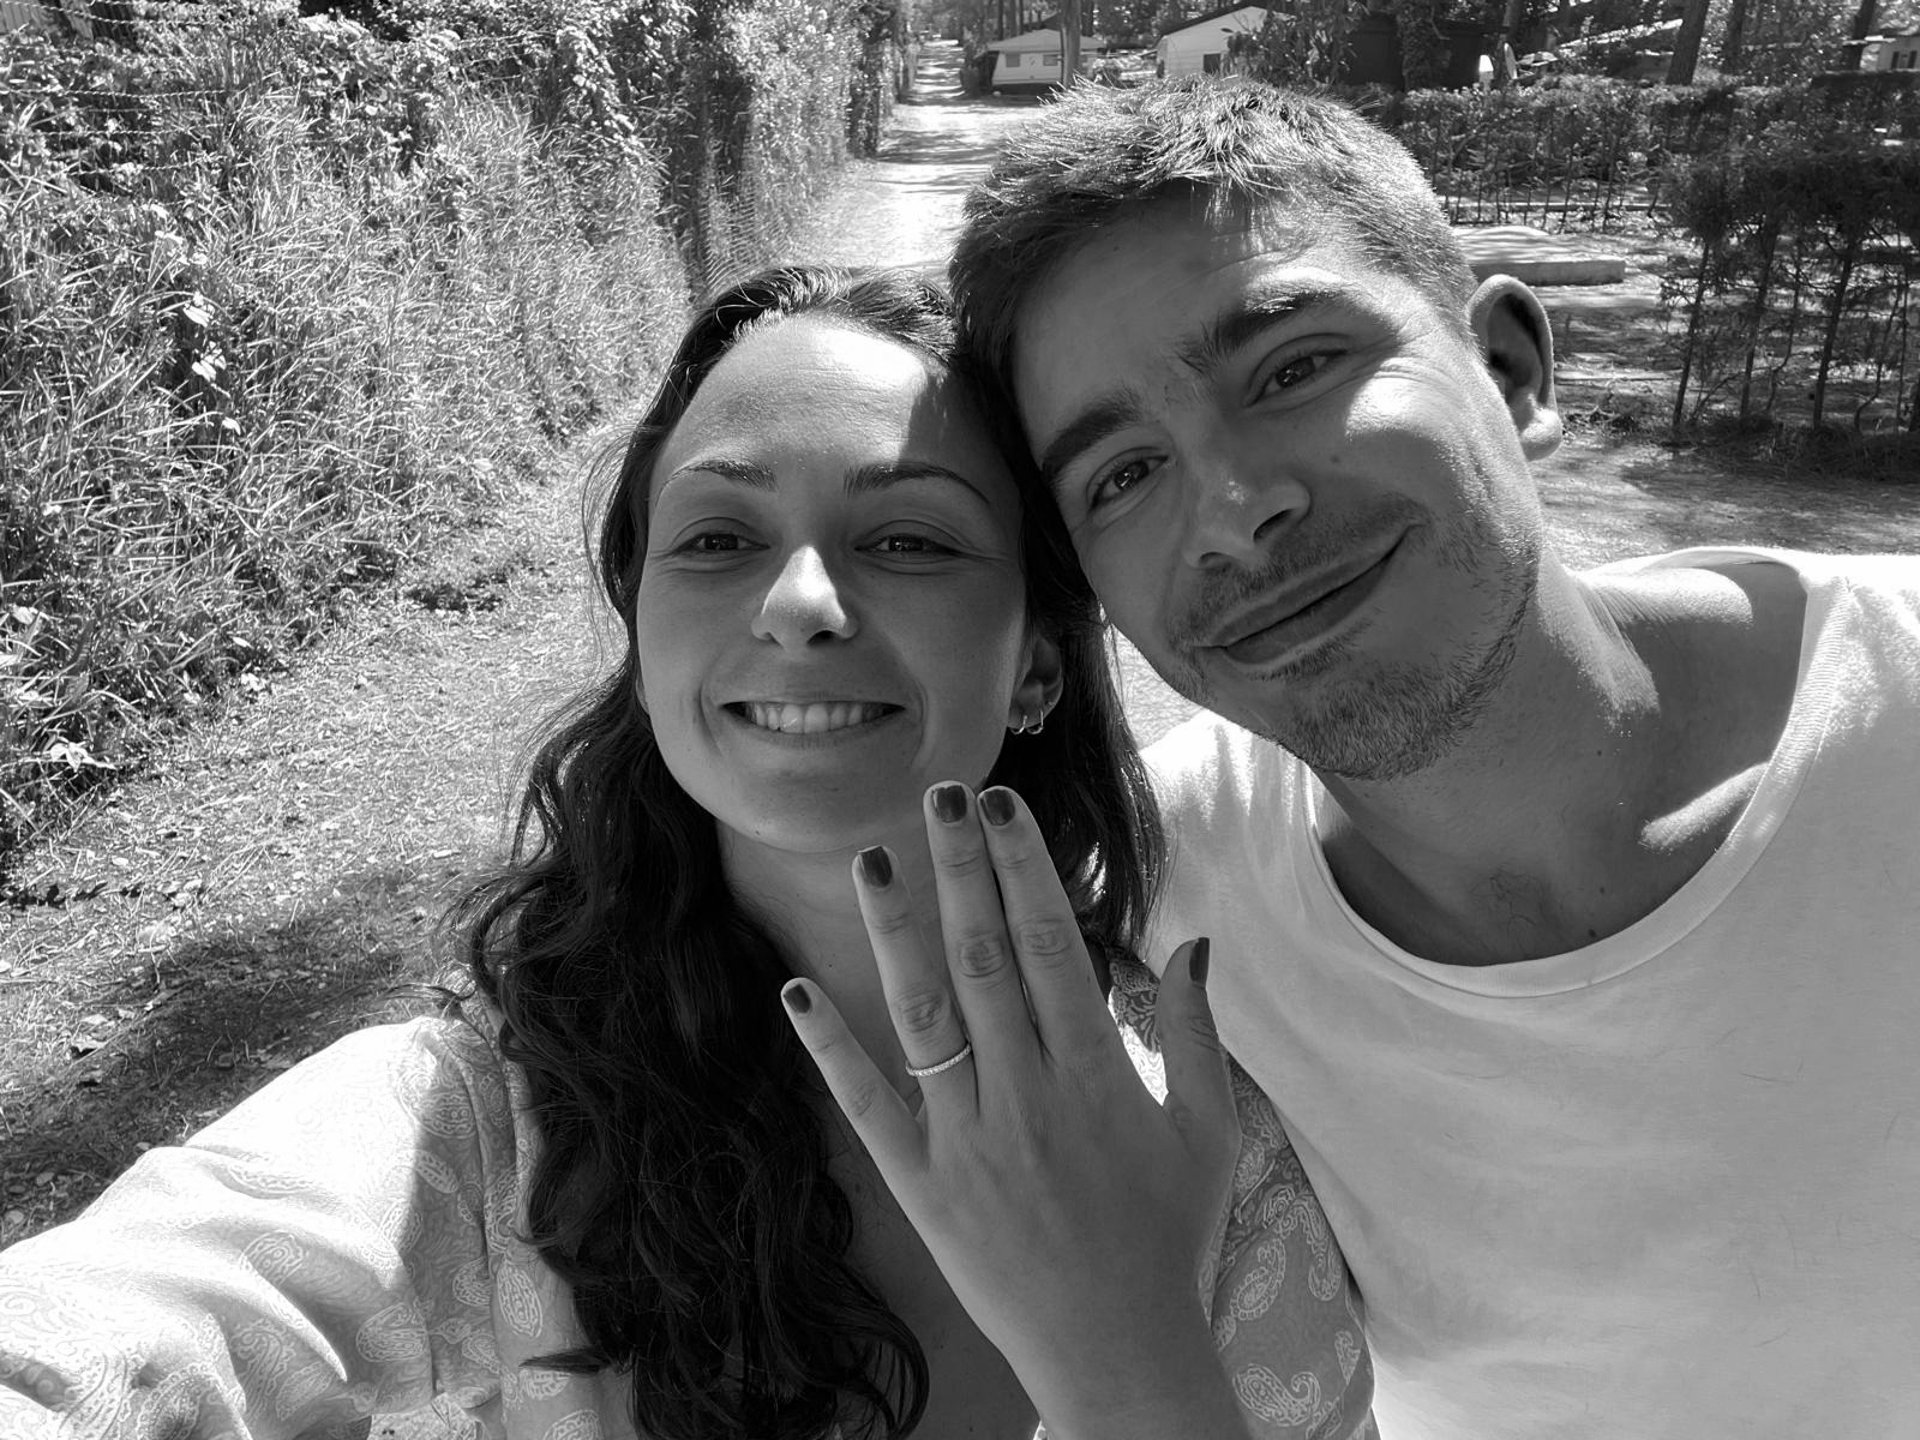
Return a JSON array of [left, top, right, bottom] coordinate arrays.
[[1112, 960, 1379, 1440]]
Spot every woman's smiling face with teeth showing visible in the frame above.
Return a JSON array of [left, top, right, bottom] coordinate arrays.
[[636, 317, 1058, 851]]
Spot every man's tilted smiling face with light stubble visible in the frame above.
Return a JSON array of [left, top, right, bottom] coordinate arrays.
[[1014, 207, 1549, 780]]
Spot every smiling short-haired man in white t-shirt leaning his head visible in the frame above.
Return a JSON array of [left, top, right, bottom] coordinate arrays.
[[954, 81, 1920, 1440]]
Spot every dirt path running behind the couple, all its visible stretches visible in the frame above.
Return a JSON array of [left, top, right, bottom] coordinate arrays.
[[0, 48, 1920, 1244]]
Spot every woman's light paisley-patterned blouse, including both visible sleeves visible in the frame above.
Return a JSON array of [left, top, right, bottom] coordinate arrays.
[[0, 968, 1373, 1440]]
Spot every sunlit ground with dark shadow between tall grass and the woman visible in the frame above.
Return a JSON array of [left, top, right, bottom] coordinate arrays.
[[0, 426, 614, 1242]]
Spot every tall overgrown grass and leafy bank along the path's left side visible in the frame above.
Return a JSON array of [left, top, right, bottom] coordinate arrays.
[[0, 0, 890, 874]]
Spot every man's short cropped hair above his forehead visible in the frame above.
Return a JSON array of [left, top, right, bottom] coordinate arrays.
[[950, 77, 1475, 401]]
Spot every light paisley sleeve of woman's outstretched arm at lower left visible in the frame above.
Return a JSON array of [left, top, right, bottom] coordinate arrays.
[[0, 1020, 513, 1440]]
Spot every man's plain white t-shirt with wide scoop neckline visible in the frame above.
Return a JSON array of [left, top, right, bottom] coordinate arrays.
[[1146, 549, 1920, 1440]]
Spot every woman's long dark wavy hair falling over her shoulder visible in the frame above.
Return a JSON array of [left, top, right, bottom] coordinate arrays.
[[459, 267, 1160, 1440]]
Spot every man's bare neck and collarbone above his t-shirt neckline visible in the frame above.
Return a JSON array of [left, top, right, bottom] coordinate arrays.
[[1321, 561, 1805, 964]]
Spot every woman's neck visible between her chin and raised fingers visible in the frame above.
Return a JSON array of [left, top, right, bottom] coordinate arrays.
[[720, 828, 941, 1091]]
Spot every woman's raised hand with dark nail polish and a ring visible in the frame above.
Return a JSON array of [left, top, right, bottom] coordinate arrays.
[[783, 785, 1244, 1440]]
